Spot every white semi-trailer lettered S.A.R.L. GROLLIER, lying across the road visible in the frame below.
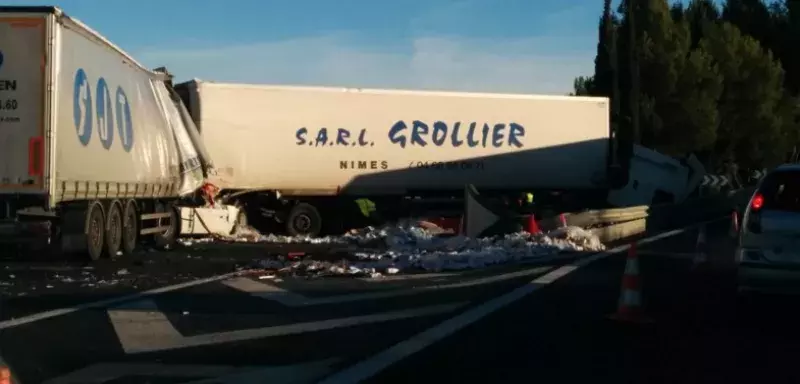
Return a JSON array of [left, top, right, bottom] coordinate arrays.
[[175, 80, 624, 235]]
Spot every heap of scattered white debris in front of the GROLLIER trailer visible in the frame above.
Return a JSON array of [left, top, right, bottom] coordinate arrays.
[[228, 224, 605, 276]]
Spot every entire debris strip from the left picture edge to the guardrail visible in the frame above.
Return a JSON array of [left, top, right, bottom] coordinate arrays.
[[0, 221, 604, 297]]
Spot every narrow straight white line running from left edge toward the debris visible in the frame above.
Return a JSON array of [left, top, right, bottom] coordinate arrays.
[[0, 271, 247, 330]]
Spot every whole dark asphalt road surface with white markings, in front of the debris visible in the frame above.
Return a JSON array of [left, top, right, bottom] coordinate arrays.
[[0, 219, 780, 384]]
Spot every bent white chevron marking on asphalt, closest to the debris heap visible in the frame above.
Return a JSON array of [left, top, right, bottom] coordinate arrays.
[[222, 267, 554, 307]]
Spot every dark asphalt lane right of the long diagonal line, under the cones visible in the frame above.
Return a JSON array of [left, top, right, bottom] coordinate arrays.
[[369, 219, 800, 383]]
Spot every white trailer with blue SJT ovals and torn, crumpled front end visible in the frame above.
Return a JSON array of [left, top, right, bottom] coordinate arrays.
[[0, 6, 211, 259]]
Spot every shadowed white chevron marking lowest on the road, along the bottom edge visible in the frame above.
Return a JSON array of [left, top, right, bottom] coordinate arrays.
[[44, 359, 339, 384]]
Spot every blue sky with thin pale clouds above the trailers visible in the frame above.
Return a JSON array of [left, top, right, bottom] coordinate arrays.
[[4, 0, 603, 94]]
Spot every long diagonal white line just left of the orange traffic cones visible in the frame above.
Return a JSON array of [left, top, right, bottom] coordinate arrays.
[[318, 217, 727, 384]]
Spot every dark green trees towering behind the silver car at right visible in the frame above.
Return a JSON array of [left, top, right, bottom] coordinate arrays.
[[574, 0, 800, 168]]
